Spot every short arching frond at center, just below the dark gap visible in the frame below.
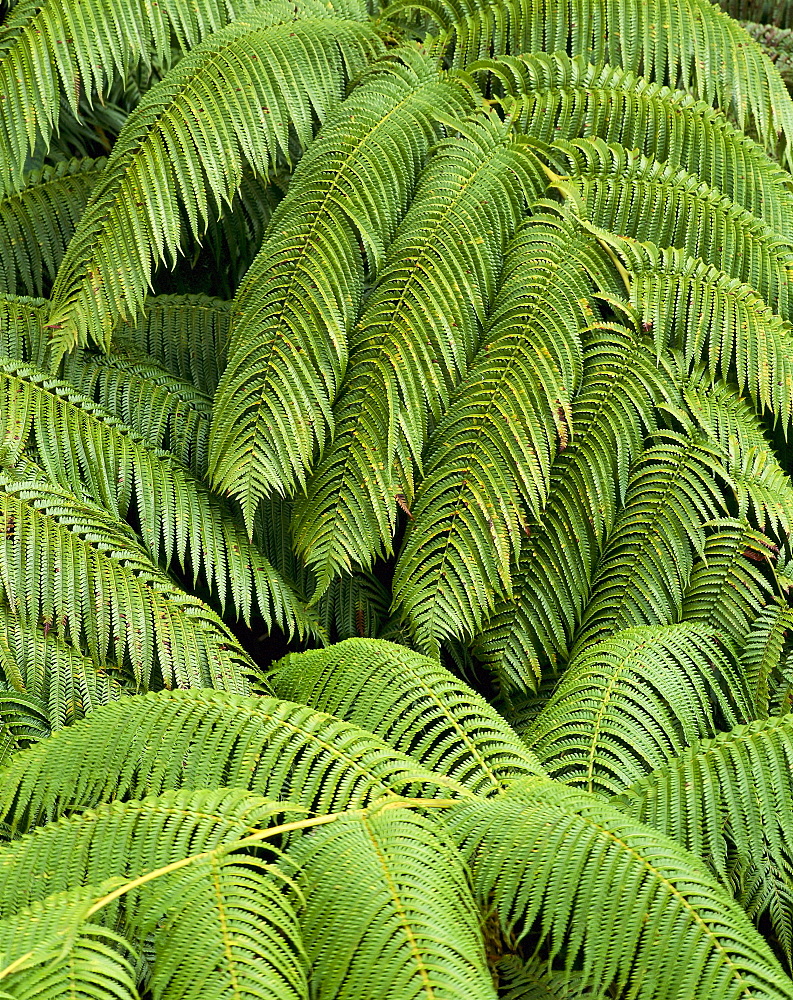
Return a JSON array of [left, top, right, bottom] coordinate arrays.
[[268, 639, 542, 795]]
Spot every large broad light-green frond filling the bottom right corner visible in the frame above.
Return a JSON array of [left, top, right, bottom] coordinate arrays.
[[446, 779, 791, 1000]]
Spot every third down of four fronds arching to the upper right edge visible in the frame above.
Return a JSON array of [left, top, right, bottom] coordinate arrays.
[[558, 139, 793, 318]]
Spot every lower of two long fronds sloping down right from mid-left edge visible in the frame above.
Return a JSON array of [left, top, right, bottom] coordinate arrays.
[[0, 463, 251, 691]]
